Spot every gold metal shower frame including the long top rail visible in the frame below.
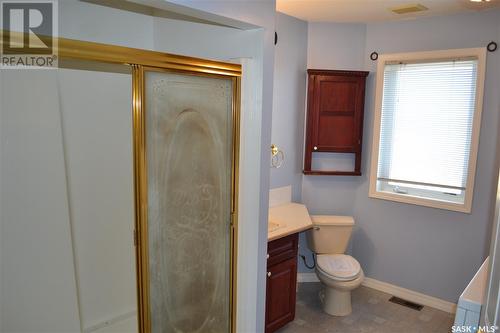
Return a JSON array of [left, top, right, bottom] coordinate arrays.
[[0, 30, 241, 333]]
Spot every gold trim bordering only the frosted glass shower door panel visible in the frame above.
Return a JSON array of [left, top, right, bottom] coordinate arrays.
[[132, 65, 241, 333]]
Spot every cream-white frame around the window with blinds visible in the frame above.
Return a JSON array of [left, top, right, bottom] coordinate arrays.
[[368, 48, 486, 214]]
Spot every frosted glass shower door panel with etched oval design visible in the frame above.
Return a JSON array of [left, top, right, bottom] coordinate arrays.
[[143, 70, 235, 333]]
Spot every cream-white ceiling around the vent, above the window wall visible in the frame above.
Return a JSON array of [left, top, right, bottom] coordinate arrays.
[[276, 0, 500, 23]]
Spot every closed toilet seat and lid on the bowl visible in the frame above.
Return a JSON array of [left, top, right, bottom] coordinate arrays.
[[316, 254, 361, 281]]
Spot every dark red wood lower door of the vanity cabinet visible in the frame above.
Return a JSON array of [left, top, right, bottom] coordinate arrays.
[[266, 258, 297, 333]]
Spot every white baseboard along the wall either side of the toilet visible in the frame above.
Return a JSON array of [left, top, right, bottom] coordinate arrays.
[[297, 273, 457, 313]]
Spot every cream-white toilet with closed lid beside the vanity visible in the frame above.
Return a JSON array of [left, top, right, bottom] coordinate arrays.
[[307, 215, 365, 316]]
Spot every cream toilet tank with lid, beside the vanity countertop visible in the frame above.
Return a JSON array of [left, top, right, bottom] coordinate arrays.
[[307, 215, 354, 254]]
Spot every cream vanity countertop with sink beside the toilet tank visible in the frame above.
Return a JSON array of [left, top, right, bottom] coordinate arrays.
[[267, 202, 312, 241]]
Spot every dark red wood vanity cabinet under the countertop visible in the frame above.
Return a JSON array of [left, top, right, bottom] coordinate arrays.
[[266, 234, 298, 333]]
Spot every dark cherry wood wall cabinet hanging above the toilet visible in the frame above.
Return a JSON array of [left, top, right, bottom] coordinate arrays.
[[304, 69, 369, 176]]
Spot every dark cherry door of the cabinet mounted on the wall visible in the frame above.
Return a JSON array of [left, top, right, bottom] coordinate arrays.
[[312, 75, 364, 152]]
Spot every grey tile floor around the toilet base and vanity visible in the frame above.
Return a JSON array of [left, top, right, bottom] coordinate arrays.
[[278, 283, 454, 333]]
